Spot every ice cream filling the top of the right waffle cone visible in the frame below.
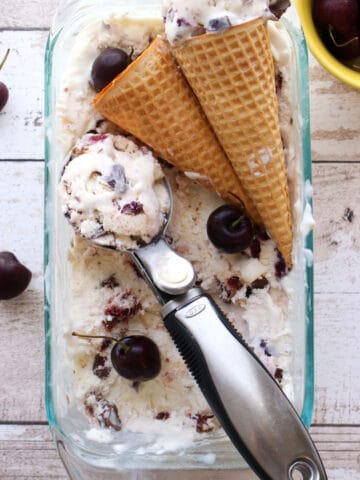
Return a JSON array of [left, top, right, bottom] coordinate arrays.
[[163, 0, 272, 43]]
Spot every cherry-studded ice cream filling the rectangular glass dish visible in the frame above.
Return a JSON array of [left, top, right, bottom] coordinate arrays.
[[57, 2, 312, 452]]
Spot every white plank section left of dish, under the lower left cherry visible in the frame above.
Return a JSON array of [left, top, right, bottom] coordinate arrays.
[[0, 161, 45, 422]]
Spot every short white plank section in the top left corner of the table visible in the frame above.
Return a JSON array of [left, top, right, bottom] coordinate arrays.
[[0, 0, 60, 29]]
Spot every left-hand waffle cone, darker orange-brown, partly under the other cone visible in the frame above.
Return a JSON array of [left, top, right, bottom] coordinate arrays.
[[93, 37, 261, 224]]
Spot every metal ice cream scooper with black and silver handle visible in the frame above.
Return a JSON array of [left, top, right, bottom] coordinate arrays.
[[60, 159, 327, 480]]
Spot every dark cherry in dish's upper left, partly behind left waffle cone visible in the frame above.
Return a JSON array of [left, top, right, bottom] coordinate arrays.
[[91, 47, 130, 92]]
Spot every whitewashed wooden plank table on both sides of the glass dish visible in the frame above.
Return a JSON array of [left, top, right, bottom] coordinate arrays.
[[0, 0, 360, 480]]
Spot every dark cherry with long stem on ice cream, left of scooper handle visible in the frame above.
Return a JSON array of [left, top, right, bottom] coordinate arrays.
[[73, 332, 161, 382]]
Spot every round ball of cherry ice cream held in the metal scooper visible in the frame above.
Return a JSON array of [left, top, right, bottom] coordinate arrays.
[[60, 134, 170, 250]]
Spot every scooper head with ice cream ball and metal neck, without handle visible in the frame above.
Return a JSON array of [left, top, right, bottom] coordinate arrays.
[[59, 132, 195, 303]]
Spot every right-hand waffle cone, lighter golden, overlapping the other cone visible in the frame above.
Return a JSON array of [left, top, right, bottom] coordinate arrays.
[[174, 19, 293, 268]]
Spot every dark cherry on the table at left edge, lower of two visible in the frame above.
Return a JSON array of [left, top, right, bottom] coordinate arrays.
[[0, 252, 32, 300]]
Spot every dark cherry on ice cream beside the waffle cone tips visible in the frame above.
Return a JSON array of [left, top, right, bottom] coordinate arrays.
[[206, 205, 254, 253]]
